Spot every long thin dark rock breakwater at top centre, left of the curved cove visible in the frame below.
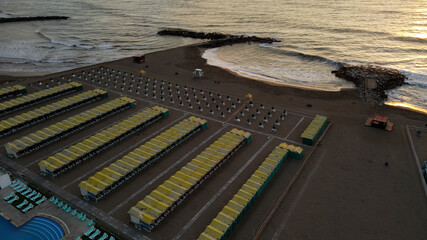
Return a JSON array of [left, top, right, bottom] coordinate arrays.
[[157, 29, 280, 48]]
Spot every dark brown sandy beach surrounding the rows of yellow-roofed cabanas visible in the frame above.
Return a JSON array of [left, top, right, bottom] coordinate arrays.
[[0, 46, 427, 240]]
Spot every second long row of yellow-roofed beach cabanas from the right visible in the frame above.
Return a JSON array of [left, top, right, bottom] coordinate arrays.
[[128, 129, 251, 231]]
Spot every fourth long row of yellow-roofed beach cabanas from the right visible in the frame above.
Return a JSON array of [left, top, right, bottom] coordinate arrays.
[[39, 106, 169, 177]]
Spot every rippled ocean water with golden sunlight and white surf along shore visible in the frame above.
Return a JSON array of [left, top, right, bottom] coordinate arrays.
[[0, 0, 427, 109]]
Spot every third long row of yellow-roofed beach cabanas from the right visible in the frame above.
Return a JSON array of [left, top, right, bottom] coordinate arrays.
[[79, 116, 207, 201]]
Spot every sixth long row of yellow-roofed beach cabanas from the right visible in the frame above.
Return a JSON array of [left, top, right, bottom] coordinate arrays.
[[0, 89, 108, 137]]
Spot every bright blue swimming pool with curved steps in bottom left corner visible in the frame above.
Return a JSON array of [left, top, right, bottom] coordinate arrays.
[[0, 216, 65, 240]]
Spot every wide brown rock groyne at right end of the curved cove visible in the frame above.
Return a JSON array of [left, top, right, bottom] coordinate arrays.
[[332, 66, 407, 105]]
